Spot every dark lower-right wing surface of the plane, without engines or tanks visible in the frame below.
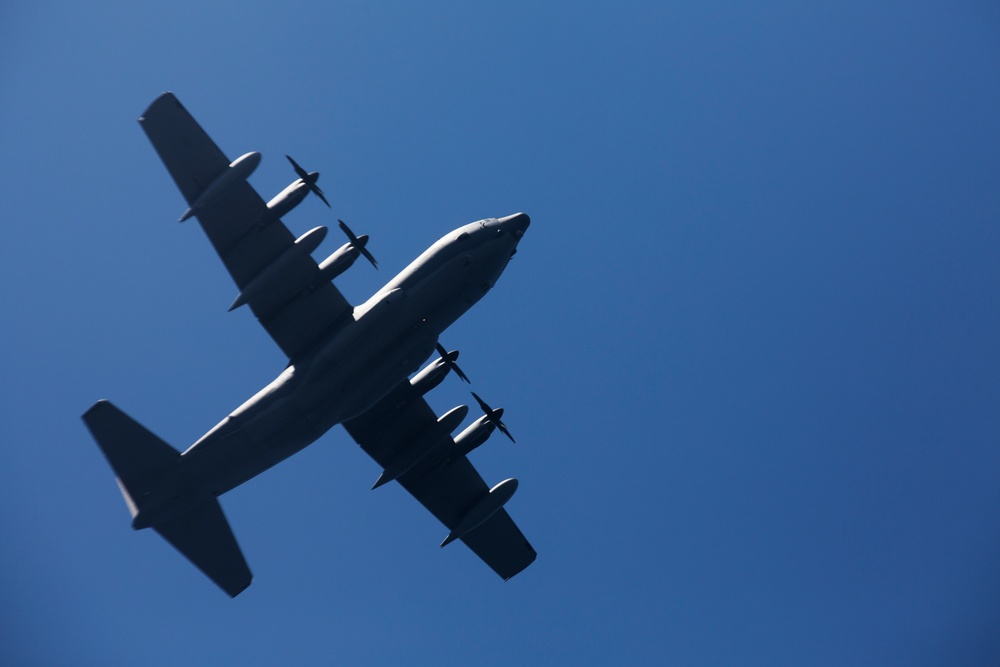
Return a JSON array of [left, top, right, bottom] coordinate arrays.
[[344, 380, 537, 580]]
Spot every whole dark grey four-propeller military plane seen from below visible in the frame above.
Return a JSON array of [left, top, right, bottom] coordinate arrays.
[[83, 93, 536, 597]]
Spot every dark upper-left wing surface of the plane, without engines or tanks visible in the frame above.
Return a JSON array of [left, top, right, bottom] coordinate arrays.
[[139, 93, 353, 359]]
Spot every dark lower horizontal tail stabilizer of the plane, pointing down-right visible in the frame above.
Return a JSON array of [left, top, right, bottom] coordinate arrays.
[[153, 498, 253, 597]]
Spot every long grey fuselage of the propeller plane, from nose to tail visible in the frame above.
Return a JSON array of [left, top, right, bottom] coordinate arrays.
[[133, 214, 529, 528]]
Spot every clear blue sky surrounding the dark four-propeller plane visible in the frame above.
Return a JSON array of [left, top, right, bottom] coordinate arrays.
[[0, 0, 1000, 665]]
